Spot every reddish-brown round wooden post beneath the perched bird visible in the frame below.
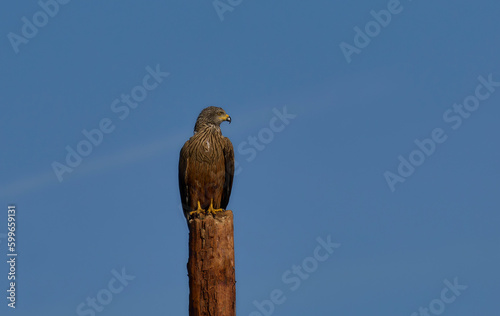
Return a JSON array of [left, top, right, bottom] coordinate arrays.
[[187, 211, 236, 316]]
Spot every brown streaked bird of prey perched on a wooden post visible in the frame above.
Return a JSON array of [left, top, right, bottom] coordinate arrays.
[[179, 106, 234, 220]]
